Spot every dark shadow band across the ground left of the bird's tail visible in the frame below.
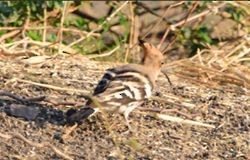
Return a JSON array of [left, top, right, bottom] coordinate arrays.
[[0, 98, 67, 127]]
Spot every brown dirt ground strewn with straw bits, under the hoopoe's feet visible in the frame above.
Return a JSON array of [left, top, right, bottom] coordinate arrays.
[[0, 56, 250, 160]]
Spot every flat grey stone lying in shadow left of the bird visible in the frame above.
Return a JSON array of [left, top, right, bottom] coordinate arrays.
[[5, 104, 40, 120]]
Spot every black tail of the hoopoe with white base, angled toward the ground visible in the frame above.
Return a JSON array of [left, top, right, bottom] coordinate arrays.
[[66, 107, 98, 124]]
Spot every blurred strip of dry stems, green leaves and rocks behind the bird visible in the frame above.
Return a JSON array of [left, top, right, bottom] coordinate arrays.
[[0, 0, 250, 62]]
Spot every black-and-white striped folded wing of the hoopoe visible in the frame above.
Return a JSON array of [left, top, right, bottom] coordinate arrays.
[[90, 65, 152, 110]]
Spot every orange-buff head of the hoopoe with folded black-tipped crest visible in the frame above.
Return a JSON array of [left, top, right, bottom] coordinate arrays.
[[139, 40, 164, 70]]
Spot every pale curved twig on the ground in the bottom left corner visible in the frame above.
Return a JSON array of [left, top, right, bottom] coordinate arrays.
[[0, 133, 73, 160]]
